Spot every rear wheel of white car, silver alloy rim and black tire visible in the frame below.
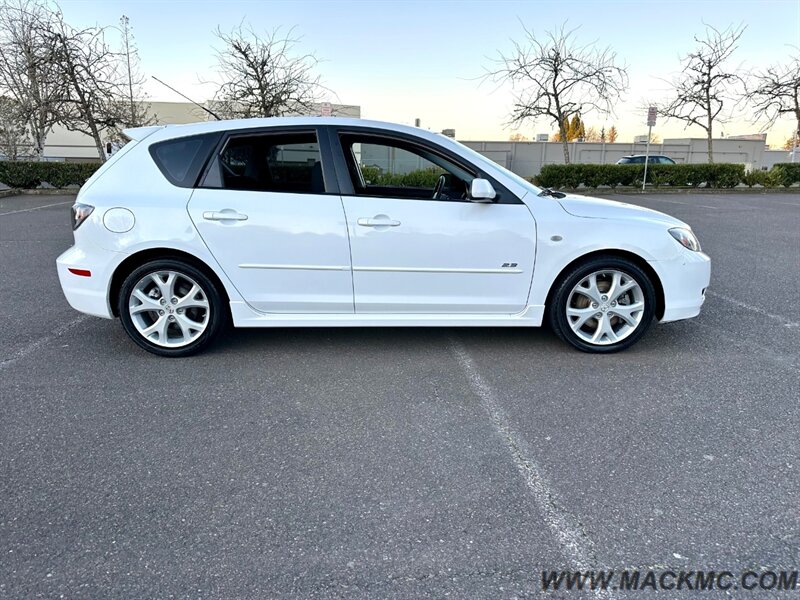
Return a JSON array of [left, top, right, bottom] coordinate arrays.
[[118, 259, 226, 357]]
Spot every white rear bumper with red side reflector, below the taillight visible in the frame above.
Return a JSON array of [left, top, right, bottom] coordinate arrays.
[[56, 246, 114, 319]]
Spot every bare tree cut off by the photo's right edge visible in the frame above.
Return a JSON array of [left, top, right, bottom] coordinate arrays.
[[745, 50, 800, 147]]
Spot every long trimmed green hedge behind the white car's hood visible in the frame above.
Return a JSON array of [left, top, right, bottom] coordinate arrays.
[[533, 163, 745, 188]]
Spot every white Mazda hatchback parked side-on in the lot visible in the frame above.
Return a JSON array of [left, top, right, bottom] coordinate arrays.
[[57, 118, 710, 356]]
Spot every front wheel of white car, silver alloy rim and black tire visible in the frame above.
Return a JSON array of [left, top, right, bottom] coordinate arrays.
[[548, 256, 655, 352]]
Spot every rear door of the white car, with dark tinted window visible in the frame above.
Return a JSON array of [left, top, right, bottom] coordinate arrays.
[[188, 127, 353, 313]]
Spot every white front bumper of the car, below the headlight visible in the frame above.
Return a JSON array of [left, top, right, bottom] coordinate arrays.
[[649, 249, 711, 323]]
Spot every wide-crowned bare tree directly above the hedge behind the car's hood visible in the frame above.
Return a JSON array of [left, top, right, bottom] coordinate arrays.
[[485, 25, 628, 163]]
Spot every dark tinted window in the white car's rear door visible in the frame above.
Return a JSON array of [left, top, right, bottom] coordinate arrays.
[[215, 132, 325, 194]]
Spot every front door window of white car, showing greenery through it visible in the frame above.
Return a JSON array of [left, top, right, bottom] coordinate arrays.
[[340, 134, 474, 200]]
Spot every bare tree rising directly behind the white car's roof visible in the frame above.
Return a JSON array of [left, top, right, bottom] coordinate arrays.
[[213, 25, 324, 118]]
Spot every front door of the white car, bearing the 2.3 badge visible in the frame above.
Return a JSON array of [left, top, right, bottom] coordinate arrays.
[[332, 133, 536, 314]]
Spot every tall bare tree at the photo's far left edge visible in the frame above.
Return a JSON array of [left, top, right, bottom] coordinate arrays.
[[0, 0, 65, 157]]
